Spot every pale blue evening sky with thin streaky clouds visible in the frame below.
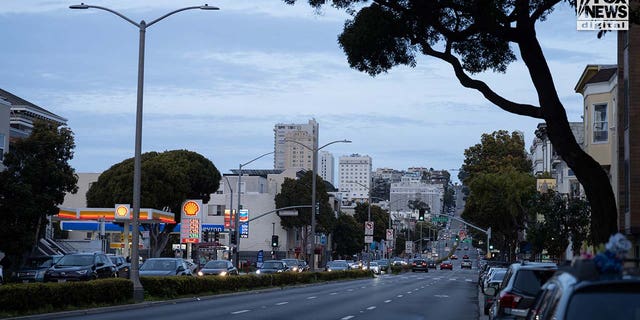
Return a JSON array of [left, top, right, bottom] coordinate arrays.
[[0, 0, 616, 184]]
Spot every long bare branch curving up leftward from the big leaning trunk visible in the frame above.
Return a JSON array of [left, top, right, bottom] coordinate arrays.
[[421, 43, 542, 119]]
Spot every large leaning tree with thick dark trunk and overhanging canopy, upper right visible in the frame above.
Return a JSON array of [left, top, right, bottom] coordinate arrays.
[[283, 0, 638, 243]]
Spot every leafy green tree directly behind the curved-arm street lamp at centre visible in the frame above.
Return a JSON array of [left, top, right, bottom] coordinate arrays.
[[275, 171, 336, 234]]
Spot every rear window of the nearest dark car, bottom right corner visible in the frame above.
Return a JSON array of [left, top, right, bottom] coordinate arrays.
[[565, 289, 640, 320]]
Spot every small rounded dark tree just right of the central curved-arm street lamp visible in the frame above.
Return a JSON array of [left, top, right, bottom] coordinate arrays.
[[333, 212, 364, 258]]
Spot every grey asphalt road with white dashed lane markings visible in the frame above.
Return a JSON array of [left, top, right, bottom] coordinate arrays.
[[41, 265, 480, 320]]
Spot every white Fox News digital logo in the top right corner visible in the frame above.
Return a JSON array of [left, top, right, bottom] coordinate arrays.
[[576, 0, 629, 31]]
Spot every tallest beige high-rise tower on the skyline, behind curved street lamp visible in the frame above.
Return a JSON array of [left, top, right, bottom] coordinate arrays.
[[273, 119, 318, 170]]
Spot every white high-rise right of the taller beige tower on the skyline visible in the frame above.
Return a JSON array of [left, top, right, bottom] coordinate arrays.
[[338, 154, 372, 205]]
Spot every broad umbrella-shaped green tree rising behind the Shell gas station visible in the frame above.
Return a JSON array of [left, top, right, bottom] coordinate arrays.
[[87, 150, 221, 257]]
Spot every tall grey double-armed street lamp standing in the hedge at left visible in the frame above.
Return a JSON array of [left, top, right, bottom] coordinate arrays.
[[69, 3, 220, 302]]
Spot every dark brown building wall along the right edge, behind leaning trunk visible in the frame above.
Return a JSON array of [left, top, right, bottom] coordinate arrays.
[[612, 16, 640, 259]]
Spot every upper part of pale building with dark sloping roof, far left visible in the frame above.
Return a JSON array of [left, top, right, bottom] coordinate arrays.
[[0, 89, 67, 141]]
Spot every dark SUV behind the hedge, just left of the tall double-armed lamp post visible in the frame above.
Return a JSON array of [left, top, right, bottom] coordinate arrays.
[[43, 253, 117, 282]]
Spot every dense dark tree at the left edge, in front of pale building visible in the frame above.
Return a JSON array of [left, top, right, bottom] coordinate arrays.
[[0, 121, 78, 268]]
